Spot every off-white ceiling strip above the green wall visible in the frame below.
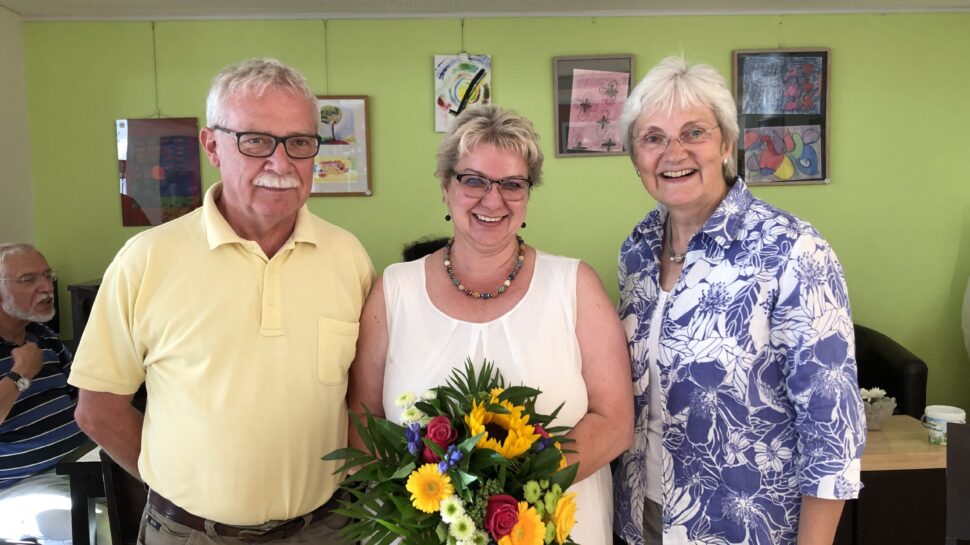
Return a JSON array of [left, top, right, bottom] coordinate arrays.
[[0, 0, 970, 20]]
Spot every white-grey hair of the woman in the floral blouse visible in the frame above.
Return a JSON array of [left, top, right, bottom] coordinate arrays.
[[620, 56, 739, 184]]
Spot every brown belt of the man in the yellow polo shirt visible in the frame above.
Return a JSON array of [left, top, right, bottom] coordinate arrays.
[[148, 490, 339, 543]]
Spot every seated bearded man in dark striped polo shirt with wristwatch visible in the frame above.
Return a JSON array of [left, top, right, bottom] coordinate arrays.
[[0, 244, 87, 543]]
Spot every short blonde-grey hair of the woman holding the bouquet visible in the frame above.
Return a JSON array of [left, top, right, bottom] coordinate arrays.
[[435, 104, 542, 188]]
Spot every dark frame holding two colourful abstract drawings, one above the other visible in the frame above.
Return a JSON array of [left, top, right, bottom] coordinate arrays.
[[733, 48, 830, 185]]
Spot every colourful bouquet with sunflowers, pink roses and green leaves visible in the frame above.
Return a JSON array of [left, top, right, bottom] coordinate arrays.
[[324, 360, 577, 545]]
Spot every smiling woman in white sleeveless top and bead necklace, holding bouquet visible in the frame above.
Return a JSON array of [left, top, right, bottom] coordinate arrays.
[[348, 106, 633, 545]]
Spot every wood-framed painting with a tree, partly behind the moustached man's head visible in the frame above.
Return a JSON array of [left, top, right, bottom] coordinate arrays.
[[311, 96, 371, 196]]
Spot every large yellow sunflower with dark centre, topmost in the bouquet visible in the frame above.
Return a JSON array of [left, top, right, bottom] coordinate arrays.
[[465, 390, 540, 460]]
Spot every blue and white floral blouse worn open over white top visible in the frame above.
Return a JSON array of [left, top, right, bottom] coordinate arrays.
[[614, 180, 866, 545]]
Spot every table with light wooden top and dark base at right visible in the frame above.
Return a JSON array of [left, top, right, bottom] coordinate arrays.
[[835, 415, 946, 545]]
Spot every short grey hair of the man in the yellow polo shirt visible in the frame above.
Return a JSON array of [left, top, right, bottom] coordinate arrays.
[[205, 59, 317, 127]]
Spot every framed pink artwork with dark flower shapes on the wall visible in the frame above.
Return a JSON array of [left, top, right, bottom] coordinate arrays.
[[552, 55, 633, 157]]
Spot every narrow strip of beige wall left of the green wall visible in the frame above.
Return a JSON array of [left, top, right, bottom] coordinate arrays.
[[0, 7, 34, 242]]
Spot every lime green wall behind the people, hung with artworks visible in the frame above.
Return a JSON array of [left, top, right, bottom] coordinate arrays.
[[24, 13, 970, 407]]
